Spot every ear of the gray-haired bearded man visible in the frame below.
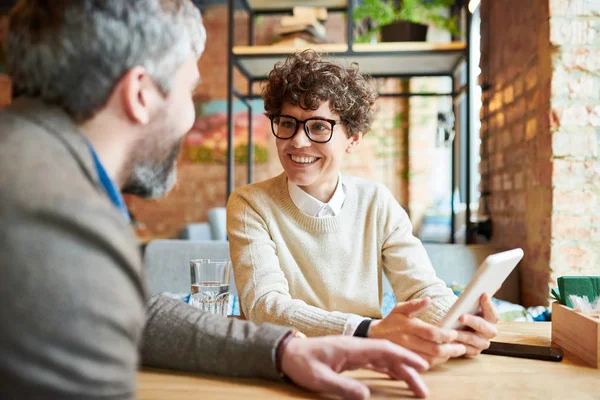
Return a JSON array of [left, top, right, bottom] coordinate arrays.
[[121, 66, 158, 125]]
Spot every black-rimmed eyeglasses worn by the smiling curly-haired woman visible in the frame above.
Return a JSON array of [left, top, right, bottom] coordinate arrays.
[[268, 115, 344, 143]]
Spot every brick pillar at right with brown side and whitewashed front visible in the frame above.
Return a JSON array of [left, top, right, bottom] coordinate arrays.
[[480, 0, 600, 305]]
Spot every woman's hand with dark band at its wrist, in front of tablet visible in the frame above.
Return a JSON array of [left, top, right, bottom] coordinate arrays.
[[369, 298, 467, 366]]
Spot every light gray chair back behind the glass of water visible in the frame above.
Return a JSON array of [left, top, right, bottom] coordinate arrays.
[[144, 239, 237, 295]]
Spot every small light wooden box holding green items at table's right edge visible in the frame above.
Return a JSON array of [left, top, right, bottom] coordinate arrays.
[[552, 302, 600, 368]]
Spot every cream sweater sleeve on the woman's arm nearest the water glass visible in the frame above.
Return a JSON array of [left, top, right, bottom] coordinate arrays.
[[227, 192, 355, 336]]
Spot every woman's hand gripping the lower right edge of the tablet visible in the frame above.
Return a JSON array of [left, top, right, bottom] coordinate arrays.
[[456, 294, 499, 356]]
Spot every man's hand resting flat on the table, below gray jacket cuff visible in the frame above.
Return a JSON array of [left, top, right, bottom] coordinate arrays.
[[281, 336, 429, 400]]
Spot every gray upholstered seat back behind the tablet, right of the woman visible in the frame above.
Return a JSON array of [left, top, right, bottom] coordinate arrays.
[[383, 243, 521, 304]]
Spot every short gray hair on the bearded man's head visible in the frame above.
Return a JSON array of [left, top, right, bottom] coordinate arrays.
[[7, 0, 206, 122]]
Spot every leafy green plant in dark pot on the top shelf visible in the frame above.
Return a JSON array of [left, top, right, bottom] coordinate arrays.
[[354, 0, 460, 43]]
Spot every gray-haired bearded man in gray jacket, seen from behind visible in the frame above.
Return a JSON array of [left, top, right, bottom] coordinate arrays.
[[0, 0, 427, 399]]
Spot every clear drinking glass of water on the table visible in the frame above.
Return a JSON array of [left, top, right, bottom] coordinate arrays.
[[189, 258, 231, 317]]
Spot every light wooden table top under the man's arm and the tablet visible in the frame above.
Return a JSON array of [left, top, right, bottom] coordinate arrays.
[[138, 322, 600, 400]]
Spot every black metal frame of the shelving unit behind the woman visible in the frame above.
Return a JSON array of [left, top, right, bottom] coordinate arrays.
[[227, 0, 471, 243]]
